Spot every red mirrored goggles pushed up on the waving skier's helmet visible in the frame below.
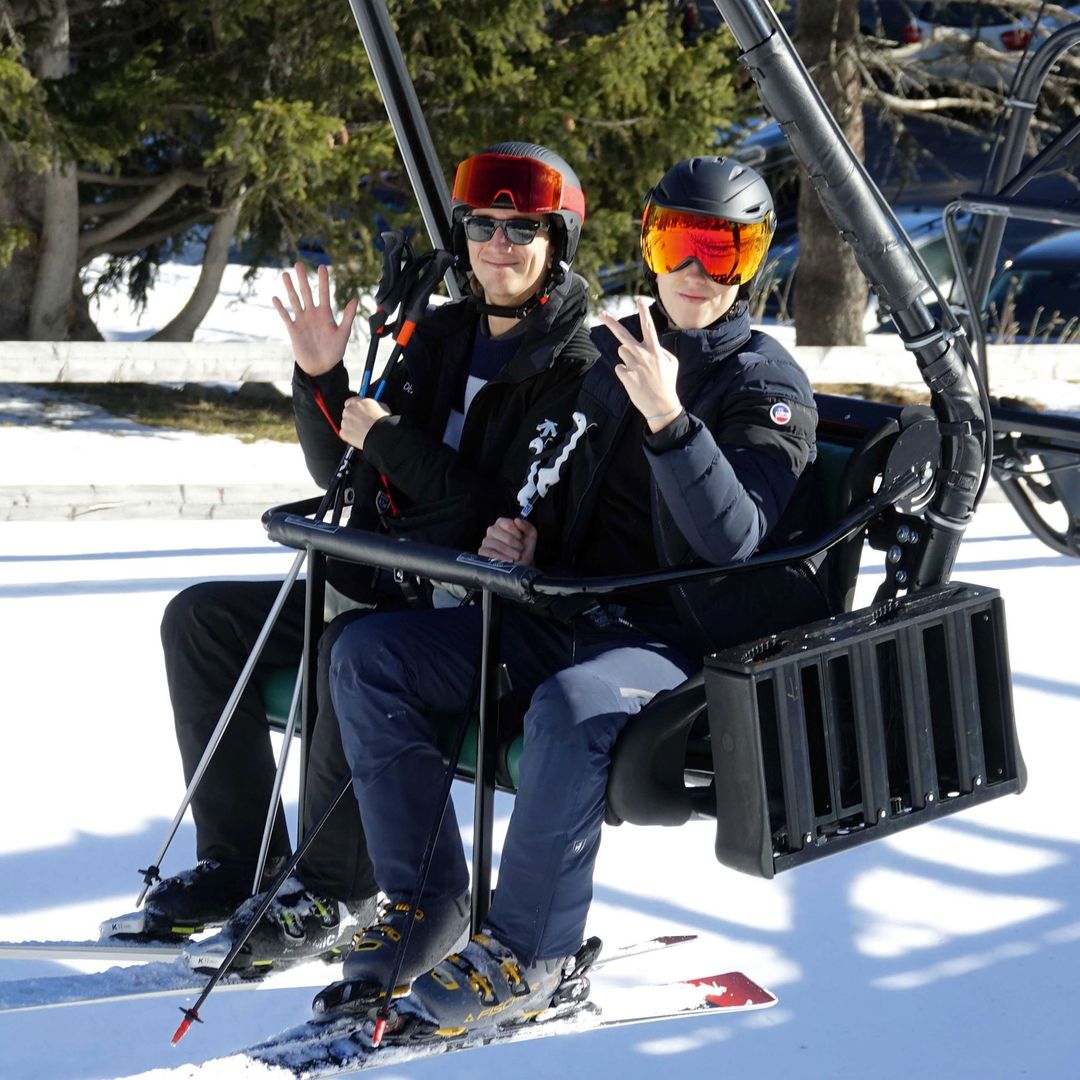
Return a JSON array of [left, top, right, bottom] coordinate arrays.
[[454, 153, 585, 220]]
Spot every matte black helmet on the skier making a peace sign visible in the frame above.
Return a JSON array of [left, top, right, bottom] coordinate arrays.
[[642, 157, 777, 297]]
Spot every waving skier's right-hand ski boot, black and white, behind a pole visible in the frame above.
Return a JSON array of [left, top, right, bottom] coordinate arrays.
[[184, 877, 377, 977]]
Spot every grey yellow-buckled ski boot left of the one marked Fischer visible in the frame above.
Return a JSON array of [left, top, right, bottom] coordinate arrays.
[[311, 892, 470, 1016]]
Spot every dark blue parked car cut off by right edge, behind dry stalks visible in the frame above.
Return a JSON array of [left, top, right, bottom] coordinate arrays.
[[987, 229, 1080, 345]]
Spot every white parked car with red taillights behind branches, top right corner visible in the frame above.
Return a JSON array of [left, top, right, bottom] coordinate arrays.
[[904, 0, 1080, 92]]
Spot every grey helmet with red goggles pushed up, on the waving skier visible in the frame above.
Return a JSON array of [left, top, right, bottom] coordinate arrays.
[[450, 143, 585, 285]]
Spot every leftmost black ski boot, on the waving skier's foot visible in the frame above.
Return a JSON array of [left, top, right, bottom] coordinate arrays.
[[100, 859, 264, 943]]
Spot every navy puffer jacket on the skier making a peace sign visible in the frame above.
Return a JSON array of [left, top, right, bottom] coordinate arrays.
[[548, 303, 827, 656]]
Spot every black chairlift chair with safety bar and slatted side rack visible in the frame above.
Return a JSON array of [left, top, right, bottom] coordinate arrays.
[[248, 0, 1025, 924]]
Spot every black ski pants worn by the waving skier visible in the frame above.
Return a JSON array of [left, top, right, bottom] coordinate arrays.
[[161, 581, 392, 901]]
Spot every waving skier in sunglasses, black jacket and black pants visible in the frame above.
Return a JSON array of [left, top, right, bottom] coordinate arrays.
[[103, 143, 596, 968]]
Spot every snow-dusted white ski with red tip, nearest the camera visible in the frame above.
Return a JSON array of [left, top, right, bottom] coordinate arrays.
[[221, 958, 777, 1078]]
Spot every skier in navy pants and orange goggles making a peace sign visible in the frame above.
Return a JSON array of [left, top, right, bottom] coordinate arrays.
[[315, 158, 825, 1036]]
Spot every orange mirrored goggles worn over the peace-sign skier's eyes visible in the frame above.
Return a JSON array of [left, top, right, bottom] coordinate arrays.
[[642, 202, 777, 285]]
